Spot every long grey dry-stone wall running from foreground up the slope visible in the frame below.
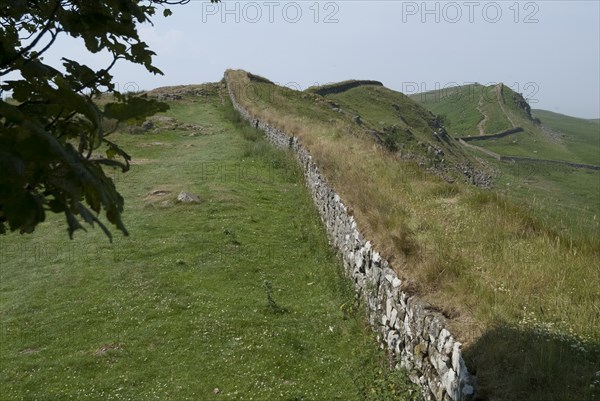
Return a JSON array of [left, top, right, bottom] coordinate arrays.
[[225, 76, 475, 401]]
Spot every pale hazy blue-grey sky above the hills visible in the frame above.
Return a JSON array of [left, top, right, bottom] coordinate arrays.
[[5, 0, 600, 118]]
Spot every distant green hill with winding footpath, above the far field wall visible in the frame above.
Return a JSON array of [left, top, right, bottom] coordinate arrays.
[[410, 84, 600, 165]]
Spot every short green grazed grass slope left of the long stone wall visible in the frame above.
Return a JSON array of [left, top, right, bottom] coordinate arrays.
[[0, 86, 416, 401]]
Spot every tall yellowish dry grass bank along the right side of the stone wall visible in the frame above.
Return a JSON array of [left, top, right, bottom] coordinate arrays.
[[227, 71, 600, 401]]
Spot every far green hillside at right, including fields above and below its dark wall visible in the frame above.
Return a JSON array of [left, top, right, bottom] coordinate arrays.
[[411, 84, 600, 238]]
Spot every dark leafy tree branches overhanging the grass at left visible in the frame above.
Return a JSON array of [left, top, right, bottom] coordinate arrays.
[[0, 0, 218, 238]]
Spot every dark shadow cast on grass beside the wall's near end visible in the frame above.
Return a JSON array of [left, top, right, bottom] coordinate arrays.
[[464, 325, 600, 401]]
